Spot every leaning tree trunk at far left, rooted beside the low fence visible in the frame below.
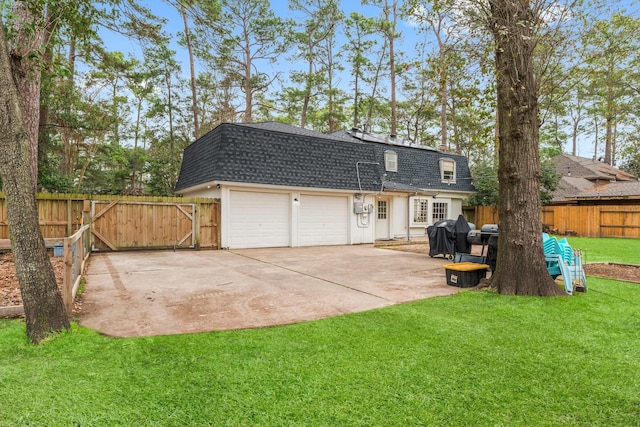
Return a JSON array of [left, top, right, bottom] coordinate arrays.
[[0, 24, 69, 343]]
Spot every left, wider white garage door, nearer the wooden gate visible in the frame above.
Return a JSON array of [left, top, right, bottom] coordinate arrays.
[[229, 191, 291, 249]]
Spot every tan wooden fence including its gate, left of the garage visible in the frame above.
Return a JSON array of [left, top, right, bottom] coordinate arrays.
[[0, 193, 220, 251]]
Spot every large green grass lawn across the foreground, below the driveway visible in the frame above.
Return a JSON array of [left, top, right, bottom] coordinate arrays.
[[0, 239, 640, 426]]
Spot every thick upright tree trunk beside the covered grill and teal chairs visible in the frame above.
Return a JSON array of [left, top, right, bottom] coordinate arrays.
[[489, 0, 565, 295]]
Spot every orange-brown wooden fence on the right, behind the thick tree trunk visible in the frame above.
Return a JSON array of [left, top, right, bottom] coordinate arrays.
[[475, 204, 640, 238]]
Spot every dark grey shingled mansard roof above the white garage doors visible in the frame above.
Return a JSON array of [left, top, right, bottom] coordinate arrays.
[[176, 122, 474, 192]]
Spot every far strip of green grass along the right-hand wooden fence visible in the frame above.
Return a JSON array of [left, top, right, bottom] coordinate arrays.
[[567, 237, 640, 264]]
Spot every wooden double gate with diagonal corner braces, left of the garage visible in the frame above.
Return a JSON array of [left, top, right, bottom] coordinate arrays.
[[91, 200, 196, 251]]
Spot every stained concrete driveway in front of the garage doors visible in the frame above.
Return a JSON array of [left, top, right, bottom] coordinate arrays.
[[80, 245, 458, 337]]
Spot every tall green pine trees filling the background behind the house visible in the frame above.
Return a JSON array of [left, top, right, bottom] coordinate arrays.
[[2, 0, 640, 197]]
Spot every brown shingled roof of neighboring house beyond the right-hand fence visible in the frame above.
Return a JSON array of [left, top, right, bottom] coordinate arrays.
[[552, 154, 640, 203]]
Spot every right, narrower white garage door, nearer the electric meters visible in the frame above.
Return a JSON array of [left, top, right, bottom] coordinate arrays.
[[299, 194, 349, 246]]
